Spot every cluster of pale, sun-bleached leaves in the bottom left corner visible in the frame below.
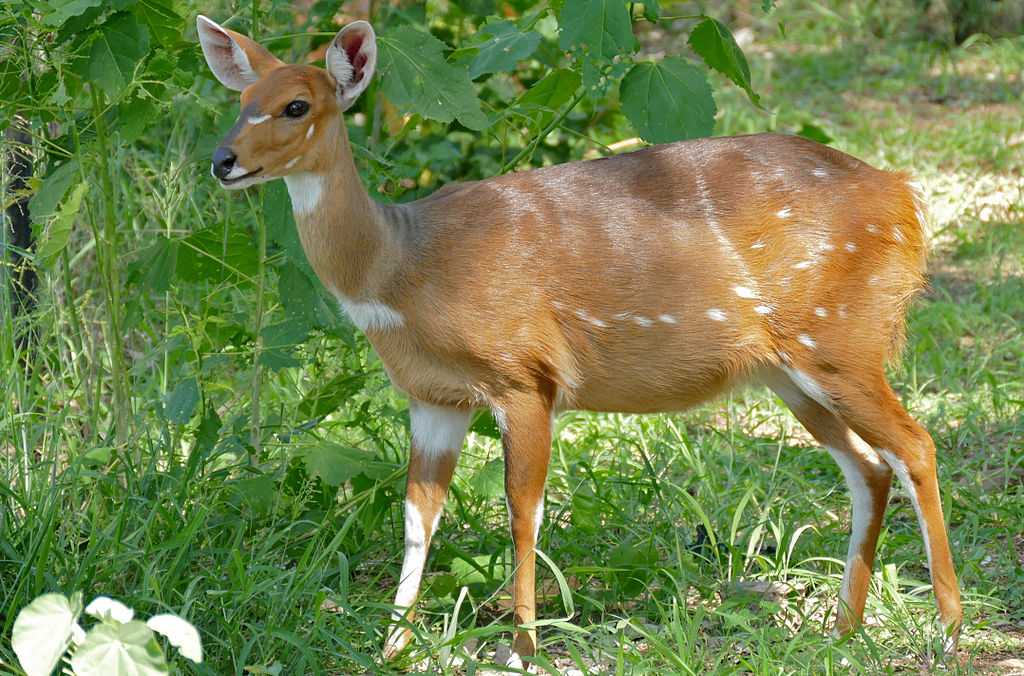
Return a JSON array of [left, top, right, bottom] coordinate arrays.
[[11, 592, 203, 676]]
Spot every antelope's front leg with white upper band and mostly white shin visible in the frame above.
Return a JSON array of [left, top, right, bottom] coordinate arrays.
[[384, 400, 472, 660]]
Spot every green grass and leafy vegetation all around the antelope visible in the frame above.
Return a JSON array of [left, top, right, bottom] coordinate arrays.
[[0, 0, 1024, 674]]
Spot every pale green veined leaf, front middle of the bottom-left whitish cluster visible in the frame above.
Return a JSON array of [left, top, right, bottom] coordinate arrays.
[[71, 620, 169, 676]]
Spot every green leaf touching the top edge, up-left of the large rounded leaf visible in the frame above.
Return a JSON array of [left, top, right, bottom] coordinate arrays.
[[558, 0, 637, 64]]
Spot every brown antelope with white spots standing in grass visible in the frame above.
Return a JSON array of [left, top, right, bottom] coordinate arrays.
[[198, 16, 962, 665]]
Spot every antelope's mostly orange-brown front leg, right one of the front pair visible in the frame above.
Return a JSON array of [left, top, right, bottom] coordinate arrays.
[[496, 397, 551, 668]]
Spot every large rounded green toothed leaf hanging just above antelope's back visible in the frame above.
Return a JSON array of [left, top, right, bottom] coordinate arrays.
[[618, 56, 716, 143]]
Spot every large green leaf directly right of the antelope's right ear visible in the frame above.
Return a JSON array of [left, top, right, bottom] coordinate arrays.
[[377, 26, 487, 130]]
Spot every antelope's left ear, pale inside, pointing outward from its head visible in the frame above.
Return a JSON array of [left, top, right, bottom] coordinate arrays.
[[196, 14, 284, 91]]
